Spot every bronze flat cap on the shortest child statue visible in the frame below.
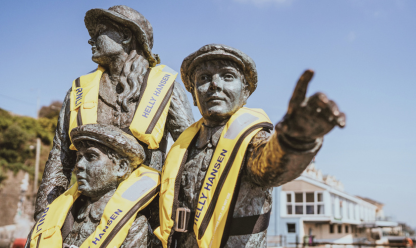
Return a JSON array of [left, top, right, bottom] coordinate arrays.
[[70, 124, 146, 166]]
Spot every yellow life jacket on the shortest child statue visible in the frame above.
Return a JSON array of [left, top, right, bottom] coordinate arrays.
[[30, 165, 160, 248]]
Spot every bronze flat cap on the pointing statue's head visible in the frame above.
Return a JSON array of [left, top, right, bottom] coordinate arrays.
[[181, 44, 257, 94]]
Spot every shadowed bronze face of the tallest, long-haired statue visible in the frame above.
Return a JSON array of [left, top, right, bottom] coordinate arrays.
[[88, 21, 126, 66]]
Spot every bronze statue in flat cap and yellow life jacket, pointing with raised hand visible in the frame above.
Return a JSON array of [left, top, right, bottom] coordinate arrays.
[[155, 44, 345, 248]]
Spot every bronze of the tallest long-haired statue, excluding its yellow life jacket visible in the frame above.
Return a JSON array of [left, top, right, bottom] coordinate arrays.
[[35, 5, 194, 220]]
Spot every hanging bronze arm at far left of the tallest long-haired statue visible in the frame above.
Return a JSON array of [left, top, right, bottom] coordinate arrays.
[[34, 89, 76, 220]]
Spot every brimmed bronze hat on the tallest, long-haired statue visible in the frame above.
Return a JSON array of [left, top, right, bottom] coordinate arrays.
[[84, 5, 160, 67]]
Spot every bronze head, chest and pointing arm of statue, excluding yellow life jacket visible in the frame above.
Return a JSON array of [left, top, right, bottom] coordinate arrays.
[[177, 44, 345, 248]]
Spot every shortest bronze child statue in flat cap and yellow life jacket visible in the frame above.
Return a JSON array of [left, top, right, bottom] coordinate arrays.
[[26, 124, 160, 248]]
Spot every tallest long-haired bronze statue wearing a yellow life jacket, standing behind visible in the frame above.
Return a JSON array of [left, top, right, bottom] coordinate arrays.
[[35, 6, 194, 220]]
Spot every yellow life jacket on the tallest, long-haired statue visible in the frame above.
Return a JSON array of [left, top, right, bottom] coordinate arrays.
[[69, 65, 178, 150]]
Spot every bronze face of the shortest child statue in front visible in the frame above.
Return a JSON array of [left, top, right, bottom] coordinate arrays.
[[75, 147, 119, 198]]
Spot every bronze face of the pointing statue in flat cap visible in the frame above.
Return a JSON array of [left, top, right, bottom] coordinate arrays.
[[194, 61, 249, 124]]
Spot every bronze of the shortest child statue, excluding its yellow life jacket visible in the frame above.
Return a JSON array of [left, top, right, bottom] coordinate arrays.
[[62, 124, 158, 247]]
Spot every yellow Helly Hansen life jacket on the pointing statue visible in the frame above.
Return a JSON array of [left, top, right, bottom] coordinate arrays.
[[154, 108, 273, 248]]
